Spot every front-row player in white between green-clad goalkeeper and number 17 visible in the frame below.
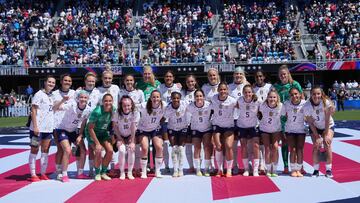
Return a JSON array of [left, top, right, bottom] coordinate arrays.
[[112, 95, 140, 180]]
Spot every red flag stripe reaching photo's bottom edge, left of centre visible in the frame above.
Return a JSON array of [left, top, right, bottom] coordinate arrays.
[[66, 177, 152, 203]]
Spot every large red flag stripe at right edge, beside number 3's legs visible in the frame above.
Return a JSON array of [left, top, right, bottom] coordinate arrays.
[[304, 143, 360, 183]]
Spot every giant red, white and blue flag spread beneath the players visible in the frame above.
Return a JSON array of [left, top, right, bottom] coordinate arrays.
[[0, 121, 360, 203]]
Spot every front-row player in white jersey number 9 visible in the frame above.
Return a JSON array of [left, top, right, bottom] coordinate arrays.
[[187, 89, 213, 176]]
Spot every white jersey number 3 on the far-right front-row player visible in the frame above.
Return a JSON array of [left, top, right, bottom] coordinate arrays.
[[304, 100, 334, 130]]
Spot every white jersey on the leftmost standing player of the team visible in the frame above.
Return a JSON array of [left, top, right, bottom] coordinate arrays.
[[30, 90, 55, 133]]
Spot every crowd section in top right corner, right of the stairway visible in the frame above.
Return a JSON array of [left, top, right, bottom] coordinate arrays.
[[304, 0, 360, 59]]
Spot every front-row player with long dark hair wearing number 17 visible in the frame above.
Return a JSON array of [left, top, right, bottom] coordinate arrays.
[[136, 90, 166, 178]]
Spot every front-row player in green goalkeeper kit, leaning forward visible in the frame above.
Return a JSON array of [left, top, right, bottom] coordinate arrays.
[[85, 94, 114, 181]]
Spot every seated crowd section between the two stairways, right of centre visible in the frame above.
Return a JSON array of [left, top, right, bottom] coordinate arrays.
[[223, 2, 299, 63]]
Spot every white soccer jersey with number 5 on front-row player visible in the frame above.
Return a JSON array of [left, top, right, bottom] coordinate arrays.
[[236, 97, 260, 128]]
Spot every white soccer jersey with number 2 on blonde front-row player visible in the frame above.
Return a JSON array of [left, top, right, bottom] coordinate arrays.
[[259, 101, 282, 133]]
